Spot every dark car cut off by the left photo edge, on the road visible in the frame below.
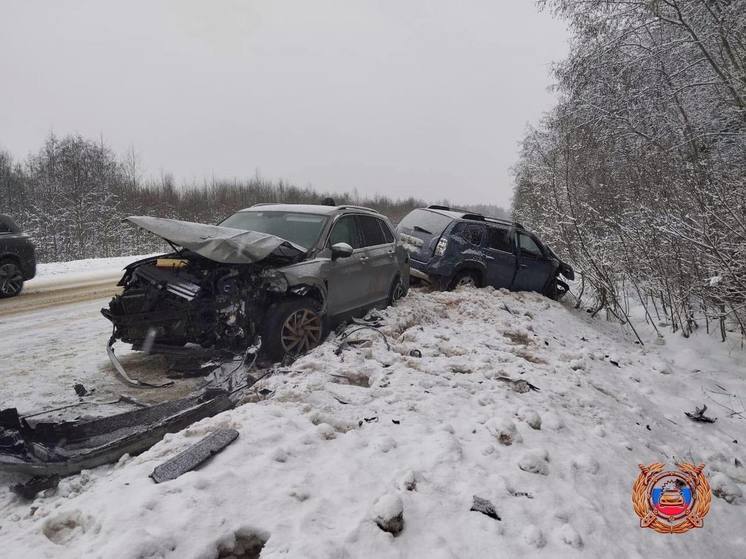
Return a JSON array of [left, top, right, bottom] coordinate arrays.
[[0, 214, 36, 298]]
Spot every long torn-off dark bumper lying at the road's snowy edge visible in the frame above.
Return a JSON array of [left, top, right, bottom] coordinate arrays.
[[0, 389, 235, 477]]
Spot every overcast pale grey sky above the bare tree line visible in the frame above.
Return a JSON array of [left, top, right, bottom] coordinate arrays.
[[0, 0, 567, 205]]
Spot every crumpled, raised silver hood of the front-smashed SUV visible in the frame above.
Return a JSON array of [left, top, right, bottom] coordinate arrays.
[[125, 216, 306, 264]]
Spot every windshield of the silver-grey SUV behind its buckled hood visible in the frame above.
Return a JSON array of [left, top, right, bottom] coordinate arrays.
[[220, 211, 327, 250]]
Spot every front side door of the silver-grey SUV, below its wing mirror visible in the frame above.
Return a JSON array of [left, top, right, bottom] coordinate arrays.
[[327, 215, 370, 316]]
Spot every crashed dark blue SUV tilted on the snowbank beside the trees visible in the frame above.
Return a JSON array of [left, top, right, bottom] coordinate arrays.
[[397, 206, 575, 299]]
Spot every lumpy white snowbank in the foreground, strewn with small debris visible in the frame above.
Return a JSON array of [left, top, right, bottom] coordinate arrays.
[[0, 288, 746, 559]]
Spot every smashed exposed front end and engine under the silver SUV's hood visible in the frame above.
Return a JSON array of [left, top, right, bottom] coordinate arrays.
[[101, 251, 287, 349]]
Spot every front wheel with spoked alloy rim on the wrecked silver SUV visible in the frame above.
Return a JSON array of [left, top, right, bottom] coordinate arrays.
[[262, 297, 324, 361]]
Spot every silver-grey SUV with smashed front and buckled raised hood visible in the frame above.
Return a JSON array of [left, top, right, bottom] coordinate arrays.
[[101, 204, 409, 359]]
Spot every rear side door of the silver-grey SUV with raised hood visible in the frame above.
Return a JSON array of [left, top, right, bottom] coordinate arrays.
[[357, 215, 398, 305]]
